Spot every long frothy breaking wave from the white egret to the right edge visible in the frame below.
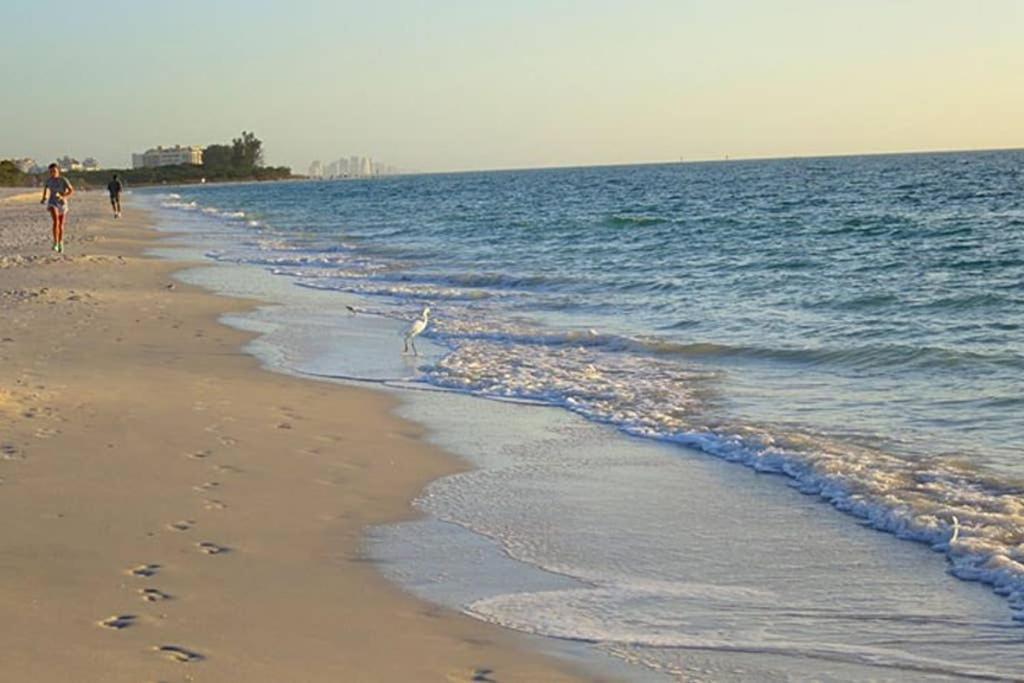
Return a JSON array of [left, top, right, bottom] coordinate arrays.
[[424, 340, 1024, 621]]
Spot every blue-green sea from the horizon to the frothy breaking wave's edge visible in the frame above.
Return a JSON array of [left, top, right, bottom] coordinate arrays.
[[147, 152, 1024, 630]]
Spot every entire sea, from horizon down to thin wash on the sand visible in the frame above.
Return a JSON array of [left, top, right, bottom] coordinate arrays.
[[142, 151, 1024, 680]]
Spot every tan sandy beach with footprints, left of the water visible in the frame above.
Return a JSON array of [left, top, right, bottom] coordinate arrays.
[[0, 193, 598, 683]]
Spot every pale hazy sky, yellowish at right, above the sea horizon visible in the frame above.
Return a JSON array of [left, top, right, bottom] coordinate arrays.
[[0, 0, 1024, 172]]
